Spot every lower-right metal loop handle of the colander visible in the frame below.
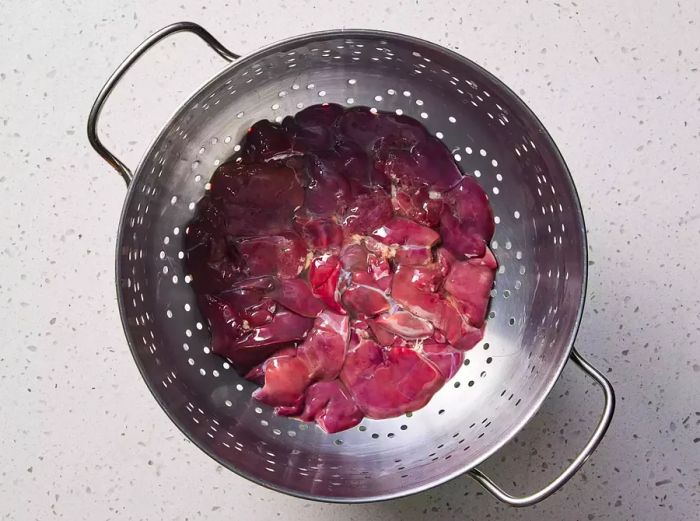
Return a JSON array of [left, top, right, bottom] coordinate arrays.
[[469, 349, 615, 507]]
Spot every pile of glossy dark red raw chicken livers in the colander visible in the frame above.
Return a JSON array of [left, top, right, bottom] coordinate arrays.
[[185, 103, 497, 433]]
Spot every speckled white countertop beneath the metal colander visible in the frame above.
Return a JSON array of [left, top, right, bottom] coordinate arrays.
[[0, 0, 700, 521]]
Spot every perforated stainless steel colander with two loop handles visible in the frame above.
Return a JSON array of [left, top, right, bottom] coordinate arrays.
[[88, 22, 614, 506]]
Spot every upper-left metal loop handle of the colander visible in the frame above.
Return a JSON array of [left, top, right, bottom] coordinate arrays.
[[87, 22, 240, 186]]
